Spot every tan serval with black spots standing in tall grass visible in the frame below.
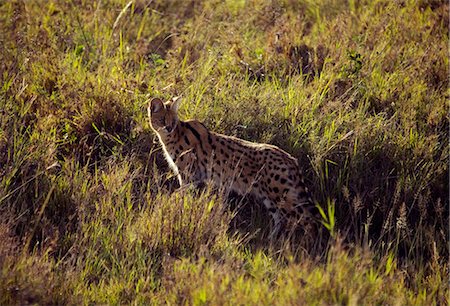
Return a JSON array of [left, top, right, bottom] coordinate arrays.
[[148, 98, 315, 233]]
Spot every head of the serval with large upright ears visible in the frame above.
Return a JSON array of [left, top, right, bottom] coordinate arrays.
[[147, 97, 181, 136]]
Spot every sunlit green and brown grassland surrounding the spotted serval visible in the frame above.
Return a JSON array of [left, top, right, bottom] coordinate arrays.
[[0, 0, 449, 305]]
